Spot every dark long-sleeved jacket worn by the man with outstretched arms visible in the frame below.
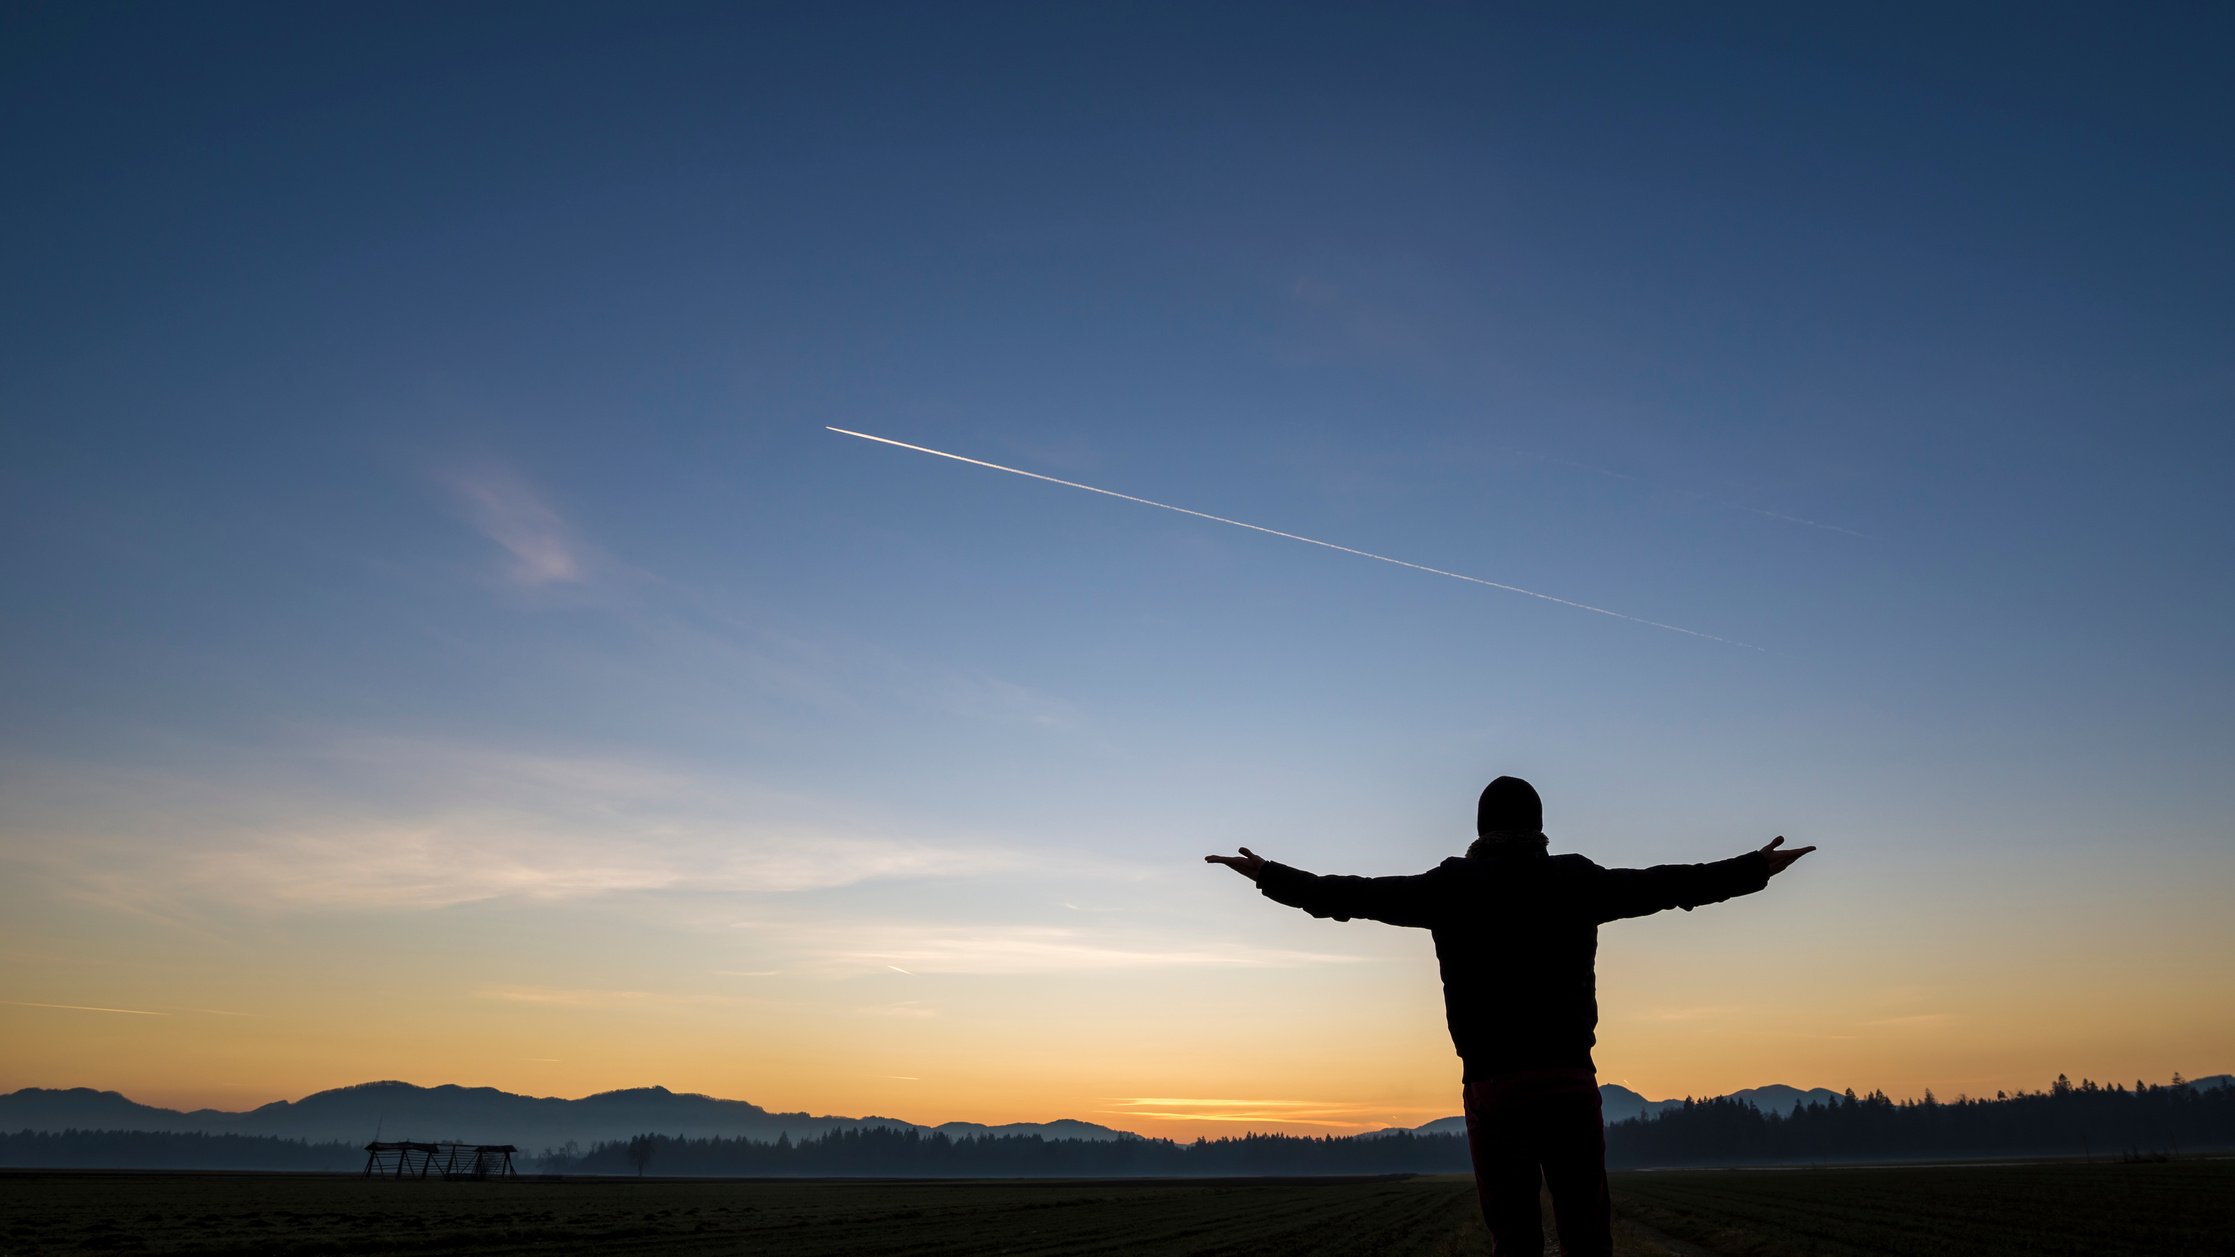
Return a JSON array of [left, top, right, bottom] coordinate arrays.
[[1258, 837, 1770, 1083]]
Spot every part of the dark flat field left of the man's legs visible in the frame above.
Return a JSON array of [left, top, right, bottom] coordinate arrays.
[[0, 1174, 1489, 1257]]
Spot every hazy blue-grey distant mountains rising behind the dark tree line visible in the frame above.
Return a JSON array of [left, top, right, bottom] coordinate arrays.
[[0, 1074, 2235, 1152]]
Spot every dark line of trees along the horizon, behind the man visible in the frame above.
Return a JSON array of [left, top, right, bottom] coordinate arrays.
[[0, 1074, 2235, 1179]]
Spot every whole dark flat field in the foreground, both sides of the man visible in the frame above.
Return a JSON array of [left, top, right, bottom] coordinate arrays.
[[0, 1161, 2235, 1257]]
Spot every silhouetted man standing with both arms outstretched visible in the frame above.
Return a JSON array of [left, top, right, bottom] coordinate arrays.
[[1202, 776, 1815, 1257]]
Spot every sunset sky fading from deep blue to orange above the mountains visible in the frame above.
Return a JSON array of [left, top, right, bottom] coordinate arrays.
[[0, 4, 2235, 1136]]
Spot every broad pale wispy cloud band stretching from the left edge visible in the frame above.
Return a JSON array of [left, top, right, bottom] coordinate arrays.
[[0, 740, 1037, 908]]
